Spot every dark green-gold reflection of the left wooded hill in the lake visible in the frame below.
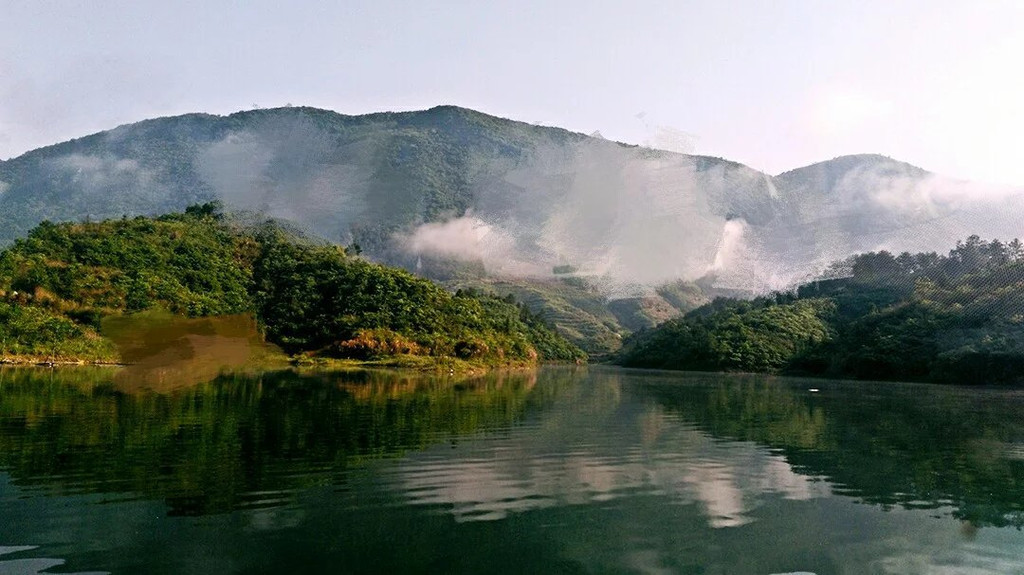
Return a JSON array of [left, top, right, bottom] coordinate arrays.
[[0, 369, 548, 515]]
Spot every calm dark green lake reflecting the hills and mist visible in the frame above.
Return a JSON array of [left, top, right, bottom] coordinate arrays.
[[0, 366, 1024, 575]]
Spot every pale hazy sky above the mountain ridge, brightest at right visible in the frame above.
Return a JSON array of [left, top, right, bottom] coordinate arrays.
[[0, 0, 1024, 185]]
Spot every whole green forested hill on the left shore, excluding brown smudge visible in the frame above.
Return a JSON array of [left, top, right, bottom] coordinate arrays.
[[0, 204, 584, 362]]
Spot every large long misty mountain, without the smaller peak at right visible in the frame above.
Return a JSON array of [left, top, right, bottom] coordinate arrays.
[[0, 106, 771, 283]]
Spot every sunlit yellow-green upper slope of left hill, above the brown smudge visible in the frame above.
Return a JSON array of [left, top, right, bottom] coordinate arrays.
[[0, 205, 251, 316]]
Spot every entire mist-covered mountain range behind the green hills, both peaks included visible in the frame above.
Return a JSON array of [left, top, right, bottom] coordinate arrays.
[[0, 106, 1024, 297]]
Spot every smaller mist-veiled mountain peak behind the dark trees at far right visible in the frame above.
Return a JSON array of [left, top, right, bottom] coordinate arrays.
[[761, 154, 1024, 284]]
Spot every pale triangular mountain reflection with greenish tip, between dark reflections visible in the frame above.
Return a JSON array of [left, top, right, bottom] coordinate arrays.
[[393, 369, 830, 527]]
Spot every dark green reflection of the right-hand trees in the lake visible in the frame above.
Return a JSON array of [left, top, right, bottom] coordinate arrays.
[[647, 375, 1024, 527]]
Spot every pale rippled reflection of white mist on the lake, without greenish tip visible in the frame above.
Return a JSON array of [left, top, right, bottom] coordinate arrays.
[[394, 413, 830, 528]]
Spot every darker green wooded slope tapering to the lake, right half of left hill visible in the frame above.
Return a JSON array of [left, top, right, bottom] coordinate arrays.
[[254, 231, 583, 361]]
